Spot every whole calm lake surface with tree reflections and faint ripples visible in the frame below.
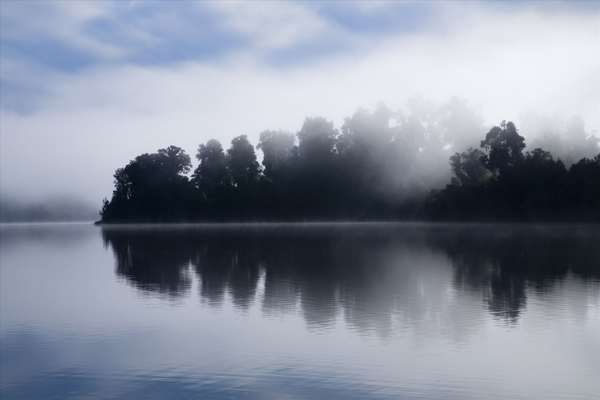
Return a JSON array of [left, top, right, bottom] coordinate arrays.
[[0, 223, 600, 400]]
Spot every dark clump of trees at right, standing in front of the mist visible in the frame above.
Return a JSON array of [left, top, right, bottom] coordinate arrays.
[[422, 121, 600, 221]]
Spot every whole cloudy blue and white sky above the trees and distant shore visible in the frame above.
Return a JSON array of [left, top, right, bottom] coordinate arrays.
[[0, 0, 600, 208]]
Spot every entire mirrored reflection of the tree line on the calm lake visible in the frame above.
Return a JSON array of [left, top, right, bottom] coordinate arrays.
[[102, 224, 600, 336]]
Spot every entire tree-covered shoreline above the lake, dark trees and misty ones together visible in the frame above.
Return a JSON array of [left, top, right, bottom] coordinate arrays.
[[99, 98, 600, 223]]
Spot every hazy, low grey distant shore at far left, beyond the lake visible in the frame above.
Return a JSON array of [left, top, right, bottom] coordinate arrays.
[[0, 196, 98, 223]]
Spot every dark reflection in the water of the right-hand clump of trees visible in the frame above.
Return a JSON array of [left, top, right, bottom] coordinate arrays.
[[430, 226, 600, 323]]
